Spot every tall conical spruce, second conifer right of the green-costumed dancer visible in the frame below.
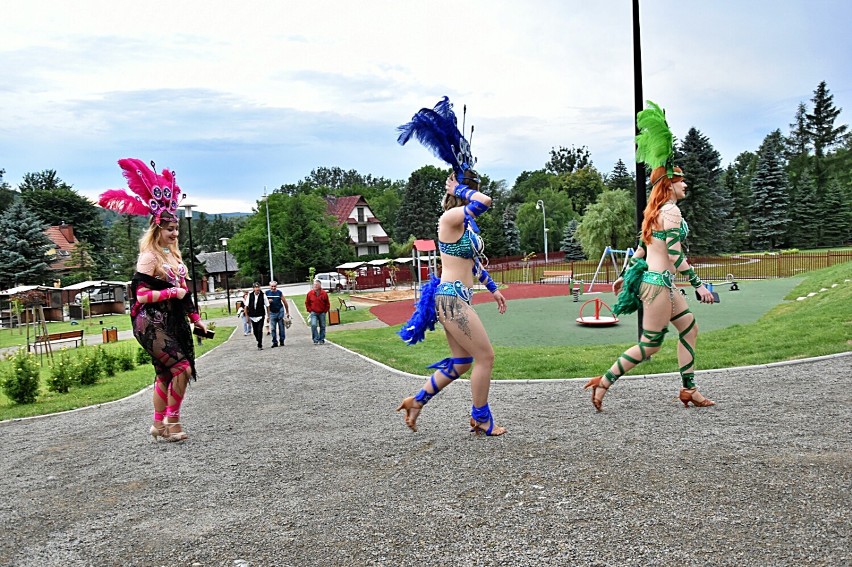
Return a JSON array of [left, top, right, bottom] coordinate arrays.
[[749, 130, 790, 249]]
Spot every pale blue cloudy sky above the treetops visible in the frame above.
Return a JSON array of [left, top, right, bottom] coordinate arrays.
[[0, 0, 852, 214]]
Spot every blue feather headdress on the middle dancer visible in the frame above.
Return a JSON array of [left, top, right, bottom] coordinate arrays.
[[397, 96, 479, 181]]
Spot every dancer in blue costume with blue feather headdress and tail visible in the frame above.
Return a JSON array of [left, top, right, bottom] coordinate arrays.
[[396, 97, 506, 436]]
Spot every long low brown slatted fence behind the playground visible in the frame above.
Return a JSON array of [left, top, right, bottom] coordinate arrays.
[[488, 250, 852, 284]]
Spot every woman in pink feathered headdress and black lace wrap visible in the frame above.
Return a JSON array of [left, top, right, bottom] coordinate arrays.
[[98, 158, 207, 441]]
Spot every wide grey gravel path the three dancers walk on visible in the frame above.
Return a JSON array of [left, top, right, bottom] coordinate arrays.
[[0, 312, 852, 567]]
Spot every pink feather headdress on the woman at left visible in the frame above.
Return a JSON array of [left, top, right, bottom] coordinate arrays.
[[98, 158, 181, 224]]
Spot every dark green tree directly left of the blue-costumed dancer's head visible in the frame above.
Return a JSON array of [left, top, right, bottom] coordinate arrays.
[[394, 165, 447, 240]]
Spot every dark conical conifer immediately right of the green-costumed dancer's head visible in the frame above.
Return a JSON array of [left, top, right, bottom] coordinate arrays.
[[675, 128, 733, 254]]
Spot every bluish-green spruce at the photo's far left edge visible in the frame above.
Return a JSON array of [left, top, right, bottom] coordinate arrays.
[[0, 201, 53, 289]]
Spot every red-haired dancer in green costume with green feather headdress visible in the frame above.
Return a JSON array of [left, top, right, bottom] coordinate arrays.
[[584, 101, 716, 411]]
